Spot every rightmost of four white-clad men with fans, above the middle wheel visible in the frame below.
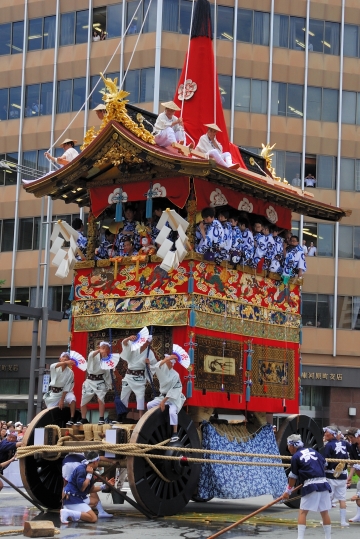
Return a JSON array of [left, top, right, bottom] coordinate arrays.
[[147, 354, 186, 443]]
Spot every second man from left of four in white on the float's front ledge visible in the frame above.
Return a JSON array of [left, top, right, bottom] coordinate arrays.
[[77, 341, 112, 425]]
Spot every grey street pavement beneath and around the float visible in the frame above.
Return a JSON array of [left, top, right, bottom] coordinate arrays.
[[0, 488, 360, 539]]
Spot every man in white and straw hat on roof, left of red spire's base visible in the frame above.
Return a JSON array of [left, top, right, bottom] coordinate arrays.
[[153, 101, 185, 148]]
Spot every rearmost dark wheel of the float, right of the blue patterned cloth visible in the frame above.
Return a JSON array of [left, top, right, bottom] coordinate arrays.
[[276, 415, 323, 509]]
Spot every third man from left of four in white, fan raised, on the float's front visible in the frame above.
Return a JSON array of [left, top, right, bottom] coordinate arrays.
[[120, 335, 156, 419]]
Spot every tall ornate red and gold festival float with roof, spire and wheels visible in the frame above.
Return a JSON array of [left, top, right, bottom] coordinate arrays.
[[17, 0, 346, 515]]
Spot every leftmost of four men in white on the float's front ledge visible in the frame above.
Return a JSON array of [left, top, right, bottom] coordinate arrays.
[[43, 352, 76, 425]]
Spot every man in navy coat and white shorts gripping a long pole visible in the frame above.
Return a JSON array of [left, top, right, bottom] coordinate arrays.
[[283, 434, 331, 539]]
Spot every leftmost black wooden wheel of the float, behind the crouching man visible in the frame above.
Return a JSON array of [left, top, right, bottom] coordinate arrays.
[[19, 407, 78, 509]]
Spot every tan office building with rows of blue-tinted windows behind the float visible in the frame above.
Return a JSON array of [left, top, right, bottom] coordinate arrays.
[[0, 0, 360, 426]]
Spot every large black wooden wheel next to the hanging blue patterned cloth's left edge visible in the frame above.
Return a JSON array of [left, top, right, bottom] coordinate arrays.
[[127, 408, 200, 516]]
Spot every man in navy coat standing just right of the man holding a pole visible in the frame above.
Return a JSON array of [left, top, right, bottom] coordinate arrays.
[[323, 425, 349, 526]]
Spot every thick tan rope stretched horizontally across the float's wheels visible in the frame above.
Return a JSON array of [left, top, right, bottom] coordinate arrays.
[[17, 442, 360, 466]]
